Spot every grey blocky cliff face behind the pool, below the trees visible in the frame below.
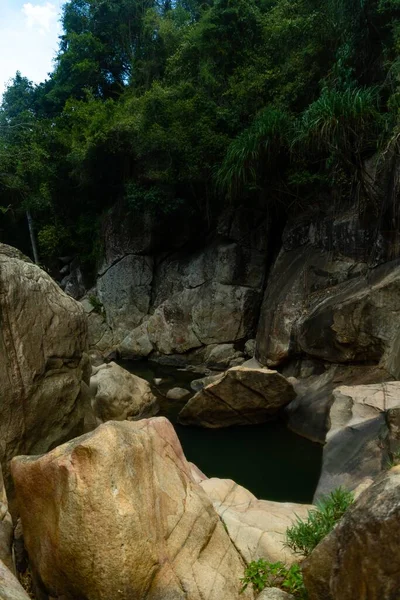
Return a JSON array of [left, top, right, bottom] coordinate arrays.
[[89, 204, 268, 357]]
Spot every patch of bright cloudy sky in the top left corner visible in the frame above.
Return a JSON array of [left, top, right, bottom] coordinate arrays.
[[0, 0, 65, 98]]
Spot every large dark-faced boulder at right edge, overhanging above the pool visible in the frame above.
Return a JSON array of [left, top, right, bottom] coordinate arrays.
[[296, 261, 400, 377]]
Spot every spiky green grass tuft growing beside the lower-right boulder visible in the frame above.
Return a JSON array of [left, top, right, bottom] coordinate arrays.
[[286, 488, 353, 556]]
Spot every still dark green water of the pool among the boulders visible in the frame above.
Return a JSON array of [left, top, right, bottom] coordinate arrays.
[[121, 361, 322, 502]]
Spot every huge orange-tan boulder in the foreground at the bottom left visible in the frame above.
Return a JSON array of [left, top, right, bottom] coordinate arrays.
[[12, 418, 253, 600]]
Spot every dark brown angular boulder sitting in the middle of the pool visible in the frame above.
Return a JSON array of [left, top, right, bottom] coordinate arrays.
[[178, 366, 295, 427]]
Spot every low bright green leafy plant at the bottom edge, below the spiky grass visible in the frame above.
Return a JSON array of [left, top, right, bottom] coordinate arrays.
[[241, 558, 307, 600]]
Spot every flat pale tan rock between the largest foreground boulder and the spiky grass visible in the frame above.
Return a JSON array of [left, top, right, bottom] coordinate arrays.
[[200, 478, 312, 565]]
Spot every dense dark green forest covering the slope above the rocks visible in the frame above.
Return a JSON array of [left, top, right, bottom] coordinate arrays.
[[0, 0, 400, 267]]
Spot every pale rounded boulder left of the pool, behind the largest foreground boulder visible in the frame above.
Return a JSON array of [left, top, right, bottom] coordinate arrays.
[[90, 362, 157, 423]]
